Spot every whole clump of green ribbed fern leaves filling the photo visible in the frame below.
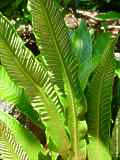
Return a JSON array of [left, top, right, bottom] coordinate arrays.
[[0, 0, 120, 160]]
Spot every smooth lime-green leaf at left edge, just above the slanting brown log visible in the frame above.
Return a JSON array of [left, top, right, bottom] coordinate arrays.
[[0, 66, 39, 122]]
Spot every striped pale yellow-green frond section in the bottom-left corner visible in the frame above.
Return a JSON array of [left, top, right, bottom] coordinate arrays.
[[0, 122, 29, 160]]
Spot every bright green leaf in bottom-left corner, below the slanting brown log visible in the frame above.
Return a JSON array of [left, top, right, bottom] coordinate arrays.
[[0, 111, 42, 160]]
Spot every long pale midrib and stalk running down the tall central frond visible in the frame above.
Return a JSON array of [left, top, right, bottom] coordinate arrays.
[[42, 2, 79, 157]]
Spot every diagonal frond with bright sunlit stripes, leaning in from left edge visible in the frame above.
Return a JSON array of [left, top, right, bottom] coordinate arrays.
[[0, 14, 68, 155]]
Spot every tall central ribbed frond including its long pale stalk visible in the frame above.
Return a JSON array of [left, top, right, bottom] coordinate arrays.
[[30, 0, 81, 159]]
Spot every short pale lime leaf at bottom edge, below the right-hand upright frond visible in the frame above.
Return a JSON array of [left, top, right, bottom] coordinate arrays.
[[87, 136, 112, 160]]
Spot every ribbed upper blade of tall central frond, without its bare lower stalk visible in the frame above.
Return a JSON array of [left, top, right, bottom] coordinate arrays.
[[30, 0, 80, 99]]
